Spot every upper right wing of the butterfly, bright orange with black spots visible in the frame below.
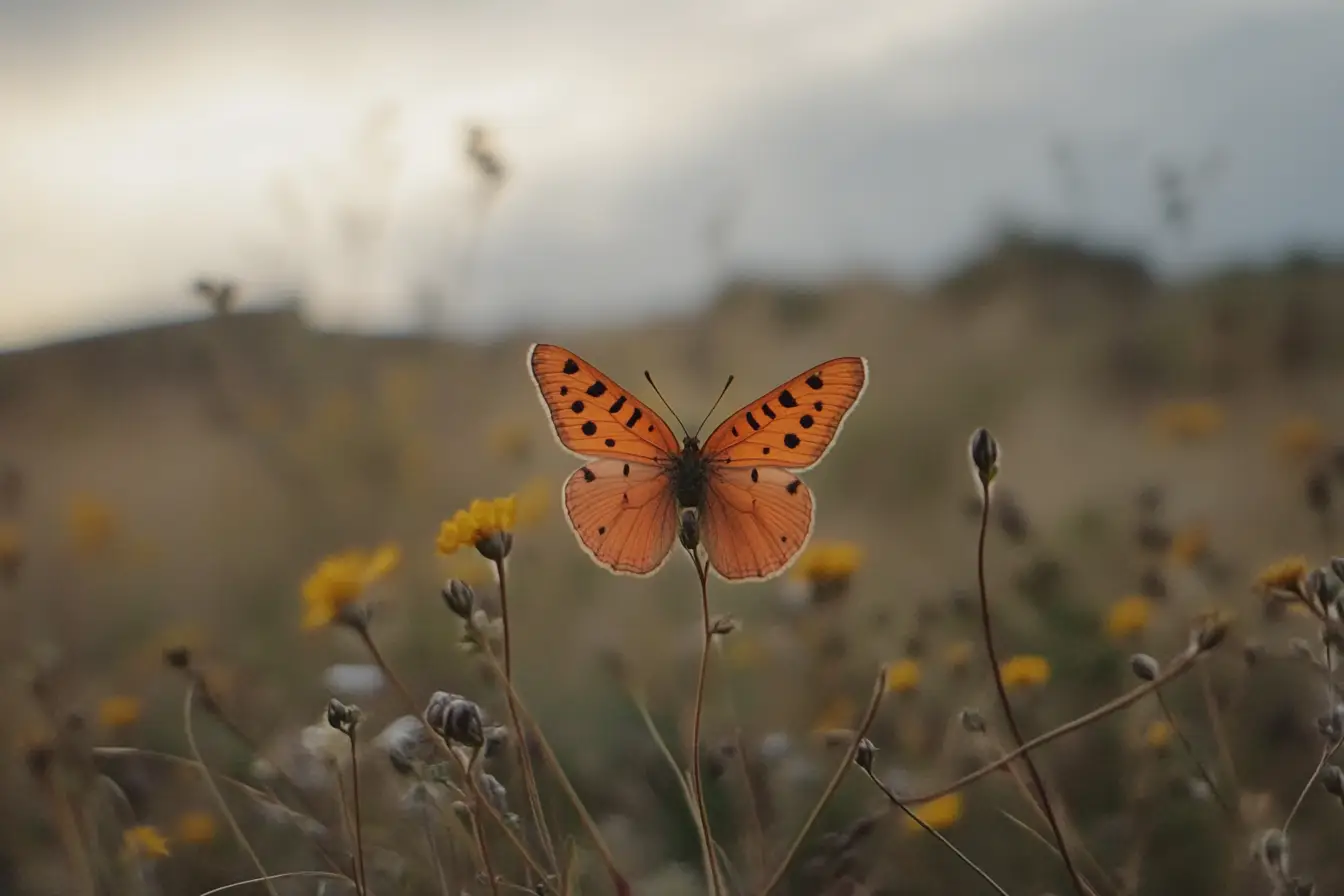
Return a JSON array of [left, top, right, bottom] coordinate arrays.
[[704, 357, 868, 470]]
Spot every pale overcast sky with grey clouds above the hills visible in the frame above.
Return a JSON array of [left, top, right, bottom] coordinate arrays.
[[0, 0, 1344, 345]]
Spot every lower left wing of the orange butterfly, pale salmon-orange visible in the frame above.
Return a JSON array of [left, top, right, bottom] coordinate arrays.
[[564, 458, 677, 575]]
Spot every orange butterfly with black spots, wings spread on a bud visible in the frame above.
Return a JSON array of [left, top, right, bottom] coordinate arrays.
[[527, 344, 868, 580]]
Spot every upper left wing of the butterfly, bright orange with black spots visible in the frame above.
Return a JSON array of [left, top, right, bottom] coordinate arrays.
[[527, 345, 681, 462]]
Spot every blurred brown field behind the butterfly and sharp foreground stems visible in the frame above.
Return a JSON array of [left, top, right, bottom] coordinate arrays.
[[0, 240, 1344, 896]]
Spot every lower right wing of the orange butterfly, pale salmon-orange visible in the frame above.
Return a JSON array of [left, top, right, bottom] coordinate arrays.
[[700, 465, 814, 580]]
